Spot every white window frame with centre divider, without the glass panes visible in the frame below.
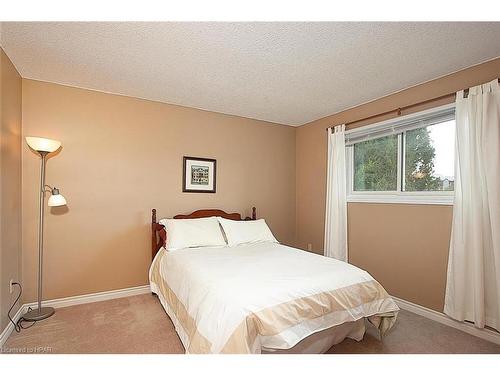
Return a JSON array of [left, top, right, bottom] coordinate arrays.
[[346, 103, 455, 205]]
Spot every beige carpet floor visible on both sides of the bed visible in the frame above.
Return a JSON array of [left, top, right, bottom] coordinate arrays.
[[3, 294, 500, 354]]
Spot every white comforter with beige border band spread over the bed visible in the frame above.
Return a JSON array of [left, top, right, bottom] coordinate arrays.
[[150, 242, 398, 353]]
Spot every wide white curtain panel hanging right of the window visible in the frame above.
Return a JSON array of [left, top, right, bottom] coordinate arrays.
[[444, 80, 500, 330]]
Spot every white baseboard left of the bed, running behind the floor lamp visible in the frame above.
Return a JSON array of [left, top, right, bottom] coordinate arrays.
[[0, 285, 151, 348]]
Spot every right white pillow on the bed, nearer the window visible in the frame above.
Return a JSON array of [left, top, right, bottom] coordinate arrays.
[[217, 217, 278, 246]]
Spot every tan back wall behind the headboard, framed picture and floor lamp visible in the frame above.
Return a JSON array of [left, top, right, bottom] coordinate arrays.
[[23, 80, 295, 301]]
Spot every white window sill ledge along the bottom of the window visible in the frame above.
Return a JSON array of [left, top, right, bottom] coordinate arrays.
[[347, 194, 453, 206]]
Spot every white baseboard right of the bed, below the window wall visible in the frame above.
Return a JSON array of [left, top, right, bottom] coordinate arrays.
[[392, 296, 500, 345]]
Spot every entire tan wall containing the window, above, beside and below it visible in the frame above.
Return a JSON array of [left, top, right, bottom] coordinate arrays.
[[296, 59, 500, 310]]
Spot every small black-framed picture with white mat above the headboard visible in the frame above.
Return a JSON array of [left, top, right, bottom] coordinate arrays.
[[182, 156, 217, 193]]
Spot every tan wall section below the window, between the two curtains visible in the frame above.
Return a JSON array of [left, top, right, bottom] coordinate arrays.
[[347, 203, 452, 311]]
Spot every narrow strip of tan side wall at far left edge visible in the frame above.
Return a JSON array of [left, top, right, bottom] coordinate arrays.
[[0, 48, 22, 332]]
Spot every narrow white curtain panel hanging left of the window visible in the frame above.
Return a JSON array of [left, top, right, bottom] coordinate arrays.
[[325, 125, 347, 262]]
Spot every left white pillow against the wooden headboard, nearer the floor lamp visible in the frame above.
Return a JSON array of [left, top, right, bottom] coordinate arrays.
[[160, 217, 226, 250]]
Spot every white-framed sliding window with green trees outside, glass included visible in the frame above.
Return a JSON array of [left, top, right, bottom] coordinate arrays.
[[346, 106, 455, 204]]
